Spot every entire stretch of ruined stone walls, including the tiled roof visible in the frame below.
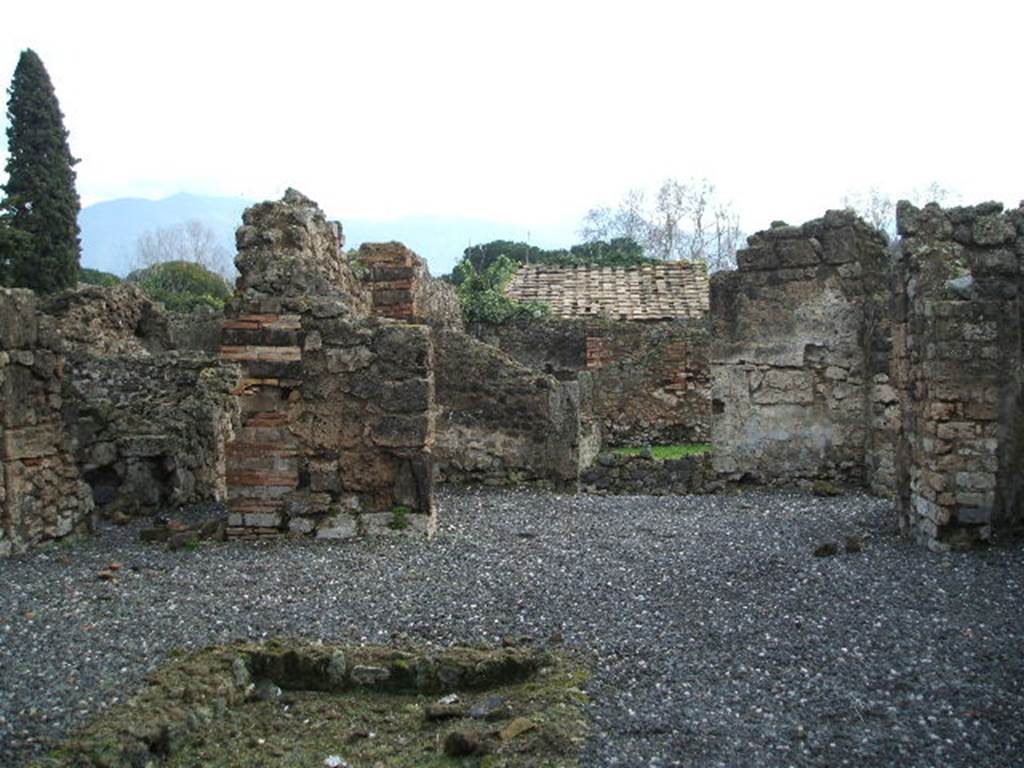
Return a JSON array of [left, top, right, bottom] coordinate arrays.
[[0, 190, 1024, 554]]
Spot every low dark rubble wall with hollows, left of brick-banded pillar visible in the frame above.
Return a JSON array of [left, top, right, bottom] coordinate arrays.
[[69, 352, 239, 518]]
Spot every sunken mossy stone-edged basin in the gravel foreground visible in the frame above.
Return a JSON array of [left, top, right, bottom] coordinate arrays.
[[35, 640, 588, 768]]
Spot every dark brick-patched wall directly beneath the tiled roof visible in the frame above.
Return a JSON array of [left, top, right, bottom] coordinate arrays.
[[473, 318, 711, 445]]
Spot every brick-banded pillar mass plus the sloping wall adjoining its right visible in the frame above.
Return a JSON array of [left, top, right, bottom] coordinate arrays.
[[222, 190, 582, 539]]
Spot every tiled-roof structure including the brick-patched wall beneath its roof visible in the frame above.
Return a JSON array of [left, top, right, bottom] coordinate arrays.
[[471, 261, 711, 445]]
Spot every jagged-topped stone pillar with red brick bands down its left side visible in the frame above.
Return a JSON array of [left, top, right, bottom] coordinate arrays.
[[222, 190, 436, 539]]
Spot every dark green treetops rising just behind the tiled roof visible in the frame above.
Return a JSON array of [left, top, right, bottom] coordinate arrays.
[[452, 238, 653, 286]]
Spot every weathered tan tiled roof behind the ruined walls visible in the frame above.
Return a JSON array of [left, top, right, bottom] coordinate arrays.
[[505, 261, 709, 321]]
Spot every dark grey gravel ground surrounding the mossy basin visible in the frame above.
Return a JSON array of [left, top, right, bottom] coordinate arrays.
[[0, 492, 1024, 768]]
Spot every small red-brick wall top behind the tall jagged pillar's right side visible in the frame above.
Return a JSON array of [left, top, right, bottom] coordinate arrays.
[[356, 243, 462, 330]]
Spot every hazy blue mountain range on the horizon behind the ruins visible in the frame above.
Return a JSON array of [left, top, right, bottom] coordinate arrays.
[[79, 194, 577, 275]]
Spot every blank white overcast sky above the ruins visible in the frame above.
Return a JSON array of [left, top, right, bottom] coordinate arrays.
[[0, 0, 1024, 229]]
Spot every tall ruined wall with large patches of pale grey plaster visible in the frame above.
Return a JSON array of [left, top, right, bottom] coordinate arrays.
[[711, 211, 899, 492]]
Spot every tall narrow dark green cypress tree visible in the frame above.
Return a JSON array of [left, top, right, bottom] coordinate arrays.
[[0, 50, 81, 292]]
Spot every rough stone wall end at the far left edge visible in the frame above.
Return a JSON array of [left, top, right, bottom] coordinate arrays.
[[0, 289, 92, 555]]
